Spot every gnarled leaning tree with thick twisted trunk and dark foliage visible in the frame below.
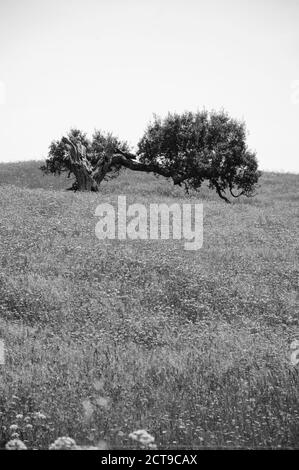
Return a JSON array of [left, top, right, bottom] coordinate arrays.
[[41, 111, 260, 202]]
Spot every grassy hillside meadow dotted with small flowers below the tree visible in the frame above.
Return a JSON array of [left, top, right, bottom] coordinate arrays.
[[0, 162, 299, 449]]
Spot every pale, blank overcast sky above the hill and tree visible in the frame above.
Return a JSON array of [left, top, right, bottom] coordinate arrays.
[[0, 0, 299, 172]]
